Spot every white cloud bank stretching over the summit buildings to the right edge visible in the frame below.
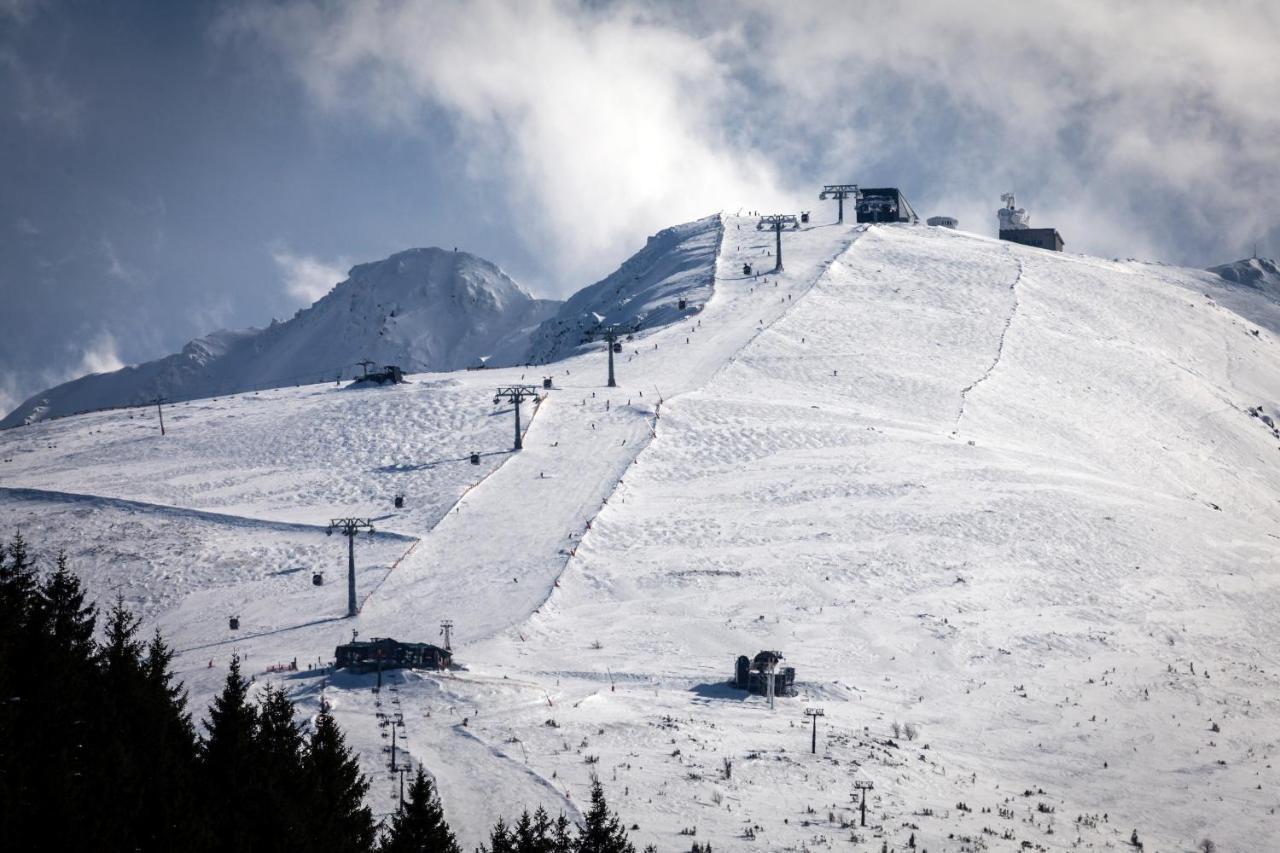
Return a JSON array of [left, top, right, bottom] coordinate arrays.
[[216, 0, 1280, 272]]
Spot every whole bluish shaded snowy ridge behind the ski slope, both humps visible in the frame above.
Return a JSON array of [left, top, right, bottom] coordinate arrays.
[[0, 216, 721, 429]]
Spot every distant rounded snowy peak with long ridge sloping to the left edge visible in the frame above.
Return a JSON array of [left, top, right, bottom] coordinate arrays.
[[0, 248, 559, 428]]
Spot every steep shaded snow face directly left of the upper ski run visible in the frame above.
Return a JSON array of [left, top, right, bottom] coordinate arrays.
[[529, 215, 724, 364]]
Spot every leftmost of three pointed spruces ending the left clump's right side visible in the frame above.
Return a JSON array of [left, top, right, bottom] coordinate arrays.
[[201, 654, 257, 853]]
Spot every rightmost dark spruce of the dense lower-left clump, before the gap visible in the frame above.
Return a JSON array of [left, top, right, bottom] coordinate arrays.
[[302, 711, 375, 853]]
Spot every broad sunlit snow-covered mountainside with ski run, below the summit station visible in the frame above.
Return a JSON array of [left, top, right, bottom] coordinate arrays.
[[0, 216, 1280, 850]]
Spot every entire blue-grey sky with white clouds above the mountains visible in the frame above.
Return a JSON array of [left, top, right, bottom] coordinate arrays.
[[0, 0, 1280, 411]]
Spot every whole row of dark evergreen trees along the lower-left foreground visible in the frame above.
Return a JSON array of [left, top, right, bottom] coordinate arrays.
[[0, 537, 635, 853]]
